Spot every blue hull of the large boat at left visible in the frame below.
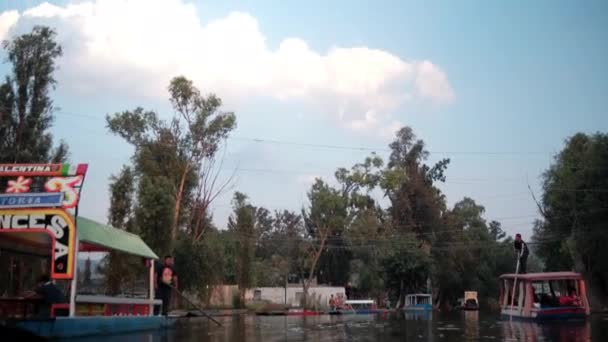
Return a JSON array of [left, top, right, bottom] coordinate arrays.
[[11, 316, 177, 338]]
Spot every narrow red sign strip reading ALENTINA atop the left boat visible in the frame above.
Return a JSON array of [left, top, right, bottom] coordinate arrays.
[[0, 164, 87, 177]]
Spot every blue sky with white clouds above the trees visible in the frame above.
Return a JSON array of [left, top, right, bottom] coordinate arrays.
[[0, 0, 608, 237]]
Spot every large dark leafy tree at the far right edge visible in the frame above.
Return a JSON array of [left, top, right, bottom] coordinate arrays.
[[534, 133, 608, 307]]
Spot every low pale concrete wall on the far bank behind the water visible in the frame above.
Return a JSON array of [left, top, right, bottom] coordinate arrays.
[[245, 286, 346, 308]]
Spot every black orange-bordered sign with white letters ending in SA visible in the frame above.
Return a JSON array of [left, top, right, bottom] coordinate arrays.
[[0, 209, 76, 279]]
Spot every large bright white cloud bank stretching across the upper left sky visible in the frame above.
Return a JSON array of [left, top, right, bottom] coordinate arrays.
[[0, 0, 454, 131]]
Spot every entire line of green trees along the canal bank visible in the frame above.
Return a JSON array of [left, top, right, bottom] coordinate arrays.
[[0, 27, 608, 307]]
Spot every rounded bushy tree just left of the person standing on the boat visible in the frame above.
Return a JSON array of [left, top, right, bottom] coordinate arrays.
[[432, 197, 533, 308]]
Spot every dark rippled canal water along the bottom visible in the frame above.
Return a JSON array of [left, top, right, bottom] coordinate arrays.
[[67, 312, 608, 342]]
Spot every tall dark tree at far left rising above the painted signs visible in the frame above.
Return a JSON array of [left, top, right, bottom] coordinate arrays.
[[0, 26, 68, 163]]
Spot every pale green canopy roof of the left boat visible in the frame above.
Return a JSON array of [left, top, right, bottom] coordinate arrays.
[[76, 216, 158, 259]]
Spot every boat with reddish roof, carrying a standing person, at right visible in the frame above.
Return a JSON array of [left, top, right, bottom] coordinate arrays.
[[499, 272, 591, 321]]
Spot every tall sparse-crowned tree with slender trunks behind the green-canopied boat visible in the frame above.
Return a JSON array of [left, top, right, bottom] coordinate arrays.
[[106, 76, 236, 250]]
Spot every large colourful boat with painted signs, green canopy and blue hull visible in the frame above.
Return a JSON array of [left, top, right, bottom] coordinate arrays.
[[0, 164, 192, 339]]
